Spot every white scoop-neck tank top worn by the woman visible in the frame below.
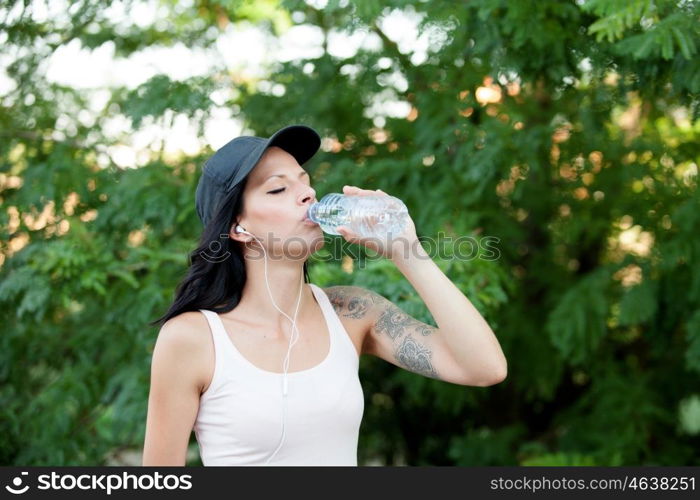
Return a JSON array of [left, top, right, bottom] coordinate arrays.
[[194, 283, 364, 466]]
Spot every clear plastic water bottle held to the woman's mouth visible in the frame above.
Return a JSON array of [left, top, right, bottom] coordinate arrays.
[[307, 193, 408, 238]]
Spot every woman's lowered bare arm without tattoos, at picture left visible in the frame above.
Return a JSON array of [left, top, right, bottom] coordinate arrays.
[[143, 312, 208, 466]]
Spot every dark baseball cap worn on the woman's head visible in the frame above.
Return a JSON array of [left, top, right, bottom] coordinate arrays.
[[195, 125, 321, 226]]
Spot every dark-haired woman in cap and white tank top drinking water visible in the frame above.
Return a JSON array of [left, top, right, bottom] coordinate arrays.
[[143, 125, 506, 465]]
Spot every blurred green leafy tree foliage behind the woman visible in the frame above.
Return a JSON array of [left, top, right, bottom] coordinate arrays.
[[0, 0, 700, 465]]
